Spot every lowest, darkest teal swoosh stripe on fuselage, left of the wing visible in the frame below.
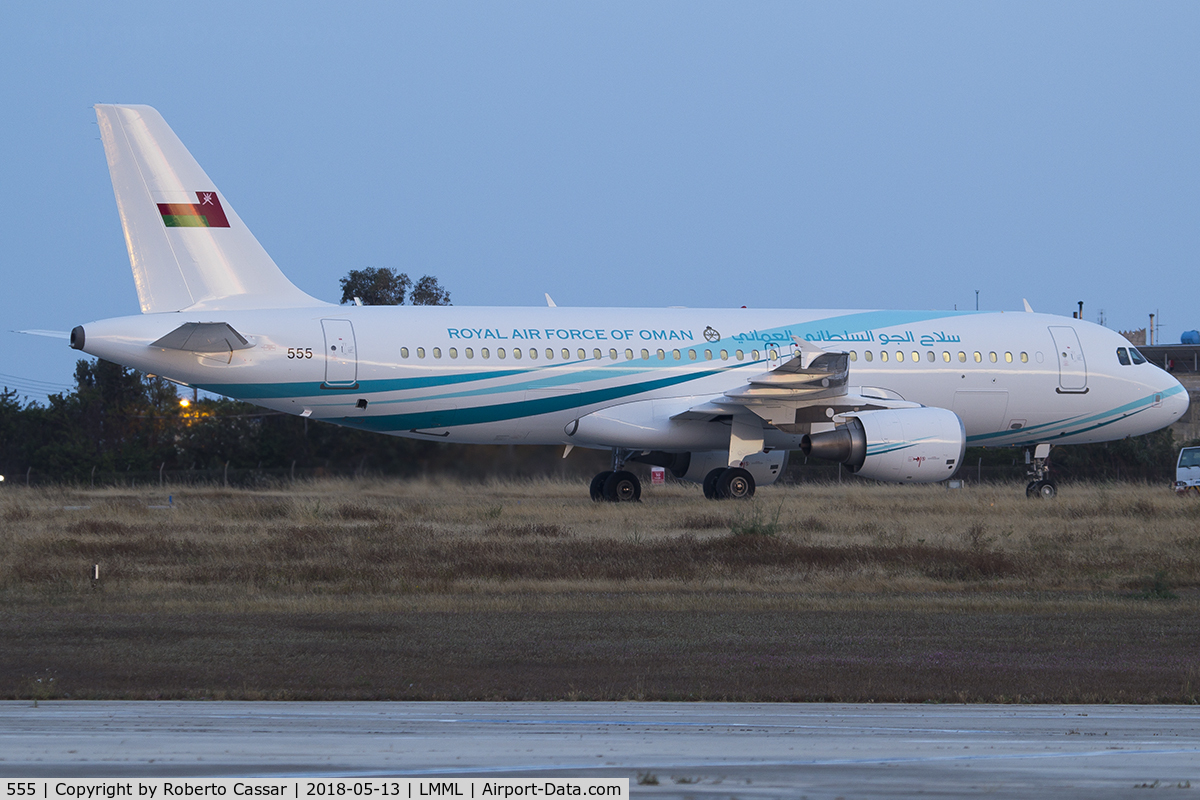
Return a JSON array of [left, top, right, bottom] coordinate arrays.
[[326, 369, 721, 433]]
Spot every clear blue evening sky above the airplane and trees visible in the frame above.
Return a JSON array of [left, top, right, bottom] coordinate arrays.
[[0, 1, 1200, 397]]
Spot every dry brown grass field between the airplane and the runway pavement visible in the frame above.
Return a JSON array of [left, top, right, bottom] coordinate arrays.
[[0, 480, 1200, 703]]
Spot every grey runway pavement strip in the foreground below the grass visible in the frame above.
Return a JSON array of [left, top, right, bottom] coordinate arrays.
[[0, 700, 1200, 799]]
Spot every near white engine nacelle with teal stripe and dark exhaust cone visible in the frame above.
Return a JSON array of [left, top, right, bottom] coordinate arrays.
[[800, 408, 967, 483]]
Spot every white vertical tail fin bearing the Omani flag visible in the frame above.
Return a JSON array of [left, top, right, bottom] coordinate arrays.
[[96, 104, 328, 314]]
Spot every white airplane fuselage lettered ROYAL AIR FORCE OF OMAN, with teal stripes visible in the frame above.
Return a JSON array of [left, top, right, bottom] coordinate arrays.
[[83, 306, 1188, 451]]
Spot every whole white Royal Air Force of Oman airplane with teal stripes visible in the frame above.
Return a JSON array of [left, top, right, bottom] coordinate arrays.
[[60, 104, 1188, 501]]
